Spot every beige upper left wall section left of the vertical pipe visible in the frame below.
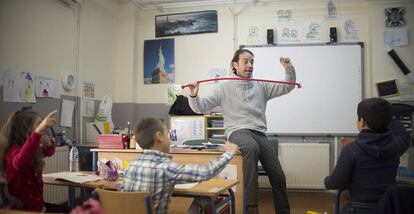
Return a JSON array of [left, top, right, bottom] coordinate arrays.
[[0, 0, 76, 95]]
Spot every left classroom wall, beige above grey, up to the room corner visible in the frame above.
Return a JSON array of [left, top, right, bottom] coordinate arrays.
[[0, 0, 135, 139]]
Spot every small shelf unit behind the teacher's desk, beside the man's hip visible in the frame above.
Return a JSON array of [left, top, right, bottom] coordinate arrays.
[[204, 113, 225, 140]]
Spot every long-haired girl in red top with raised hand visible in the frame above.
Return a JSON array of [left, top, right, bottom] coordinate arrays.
[[0, 110, 57, 211]]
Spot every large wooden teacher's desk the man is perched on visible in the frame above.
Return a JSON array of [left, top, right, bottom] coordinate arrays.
[[91, 149, 243, 213]]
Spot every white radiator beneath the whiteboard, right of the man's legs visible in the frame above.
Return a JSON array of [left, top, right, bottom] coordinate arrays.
[[259, 143, 330, 189]]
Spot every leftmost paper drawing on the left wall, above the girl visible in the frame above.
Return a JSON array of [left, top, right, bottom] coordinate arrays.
[[3, 70, 20, 102]]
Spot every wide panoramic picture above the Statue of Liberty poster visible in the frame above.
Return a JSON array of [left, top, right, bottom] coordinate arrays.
[[155, 10, 218, 37]]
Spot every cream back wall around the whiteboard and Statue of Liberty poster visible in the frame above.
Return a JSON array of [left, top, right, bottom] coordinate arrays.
[[135, 0, 414, 103]]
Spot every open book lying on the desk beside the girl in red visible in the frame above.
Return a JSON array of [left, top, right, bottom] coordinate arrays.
[[43, 172, 103, 184]]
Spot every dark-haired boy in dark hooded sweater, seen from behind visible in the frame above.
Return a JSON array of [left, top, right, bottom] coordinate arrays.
[[325, 98, 411, 213]]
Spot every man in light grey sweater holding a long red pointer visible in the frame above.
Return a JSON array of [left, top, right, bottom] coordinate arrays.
[[189, 49, 296, 214]]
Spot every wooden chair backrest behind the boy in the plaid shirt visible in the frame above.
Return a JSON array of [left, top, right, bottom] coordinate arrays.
[[95, 188, 153, 214]]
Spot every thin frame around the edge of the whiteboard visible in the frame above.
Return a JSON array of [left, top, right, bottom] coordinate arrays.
[[239, 42, 365, 137]]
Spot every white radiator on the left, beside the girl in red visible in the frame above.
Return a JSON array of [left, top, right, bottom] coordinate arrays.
[[43, 146, 69, 204]]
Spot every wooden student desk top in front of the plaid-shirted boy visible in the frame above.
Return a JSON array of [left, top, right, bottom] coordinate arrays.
[[43, 172, 239, 197]]
